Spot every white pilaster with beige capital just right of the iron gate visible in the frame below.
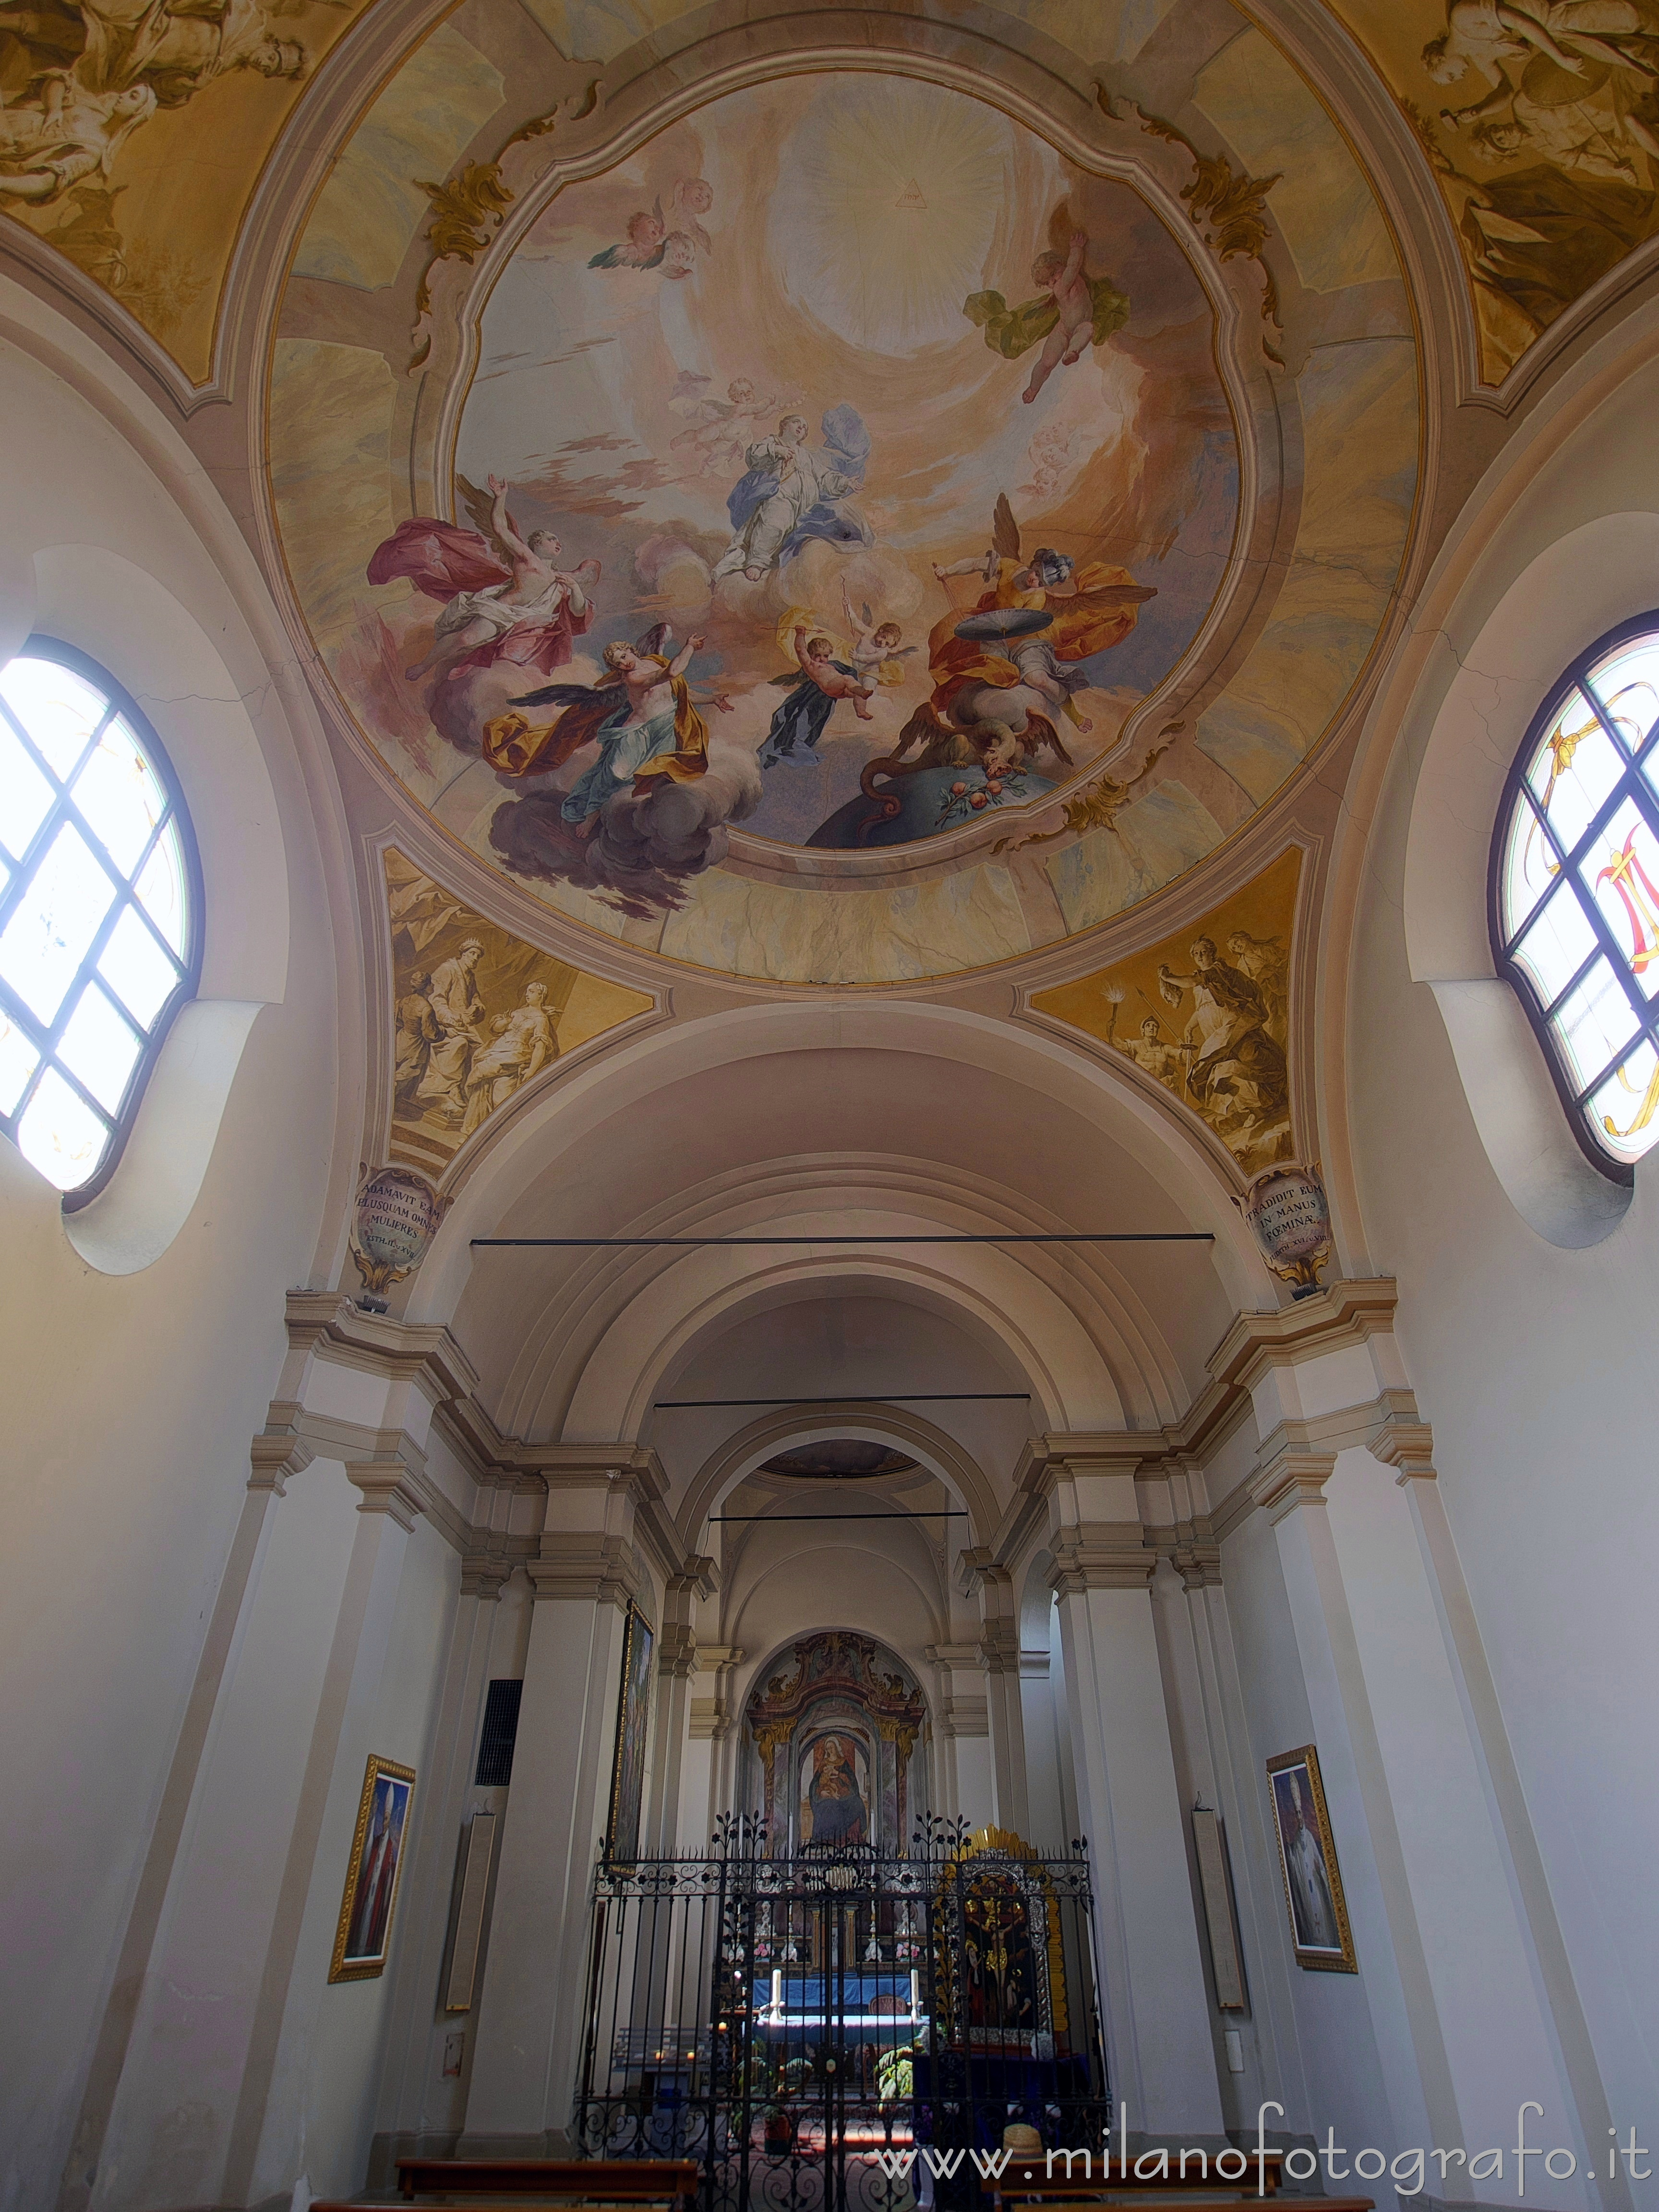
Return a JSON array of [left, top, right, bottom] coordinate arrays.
[[1040, 1453, 1221, 2137]]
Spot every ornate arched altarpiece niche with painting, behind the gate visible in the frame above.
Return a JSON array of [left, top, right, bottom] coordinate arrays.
[[741, 1628, 929, 1856]]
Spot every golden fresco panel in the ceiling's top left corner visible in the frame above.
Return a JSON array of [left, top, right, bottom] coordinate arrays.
[[0, 0, 367, 385]]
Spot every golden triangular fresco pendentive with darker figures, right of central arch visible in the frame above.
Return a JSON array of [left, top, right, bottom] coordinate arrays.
[[1031, 849, 1303, 1175]]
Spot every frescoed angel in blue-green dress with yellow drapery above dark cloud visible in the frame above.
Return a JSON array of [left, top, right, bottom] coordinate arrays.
[[482, 624, 721, 836]]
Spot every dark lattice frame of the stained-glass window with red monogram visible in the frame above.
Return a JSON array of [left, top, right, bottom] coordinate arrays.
[[1487, 608, 1659, 1188]]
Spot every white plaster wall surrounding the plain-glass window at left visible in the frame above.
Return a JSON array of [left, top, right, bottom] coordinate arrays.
[[0, 312, 347, 2208]]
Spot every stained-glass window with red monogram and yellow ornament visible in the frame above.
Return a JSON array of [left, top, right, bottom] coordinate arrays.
[[1489, 613, 1659, 1181]]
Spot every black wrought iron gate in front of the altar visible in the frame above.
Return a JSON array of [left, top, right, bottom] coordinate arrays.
[[575, 1816, 1110, 2212]]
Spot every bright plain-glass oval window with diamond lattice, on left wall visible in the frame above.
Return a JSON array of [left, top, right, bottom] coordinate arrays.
[[0, 637, 201, 1208]]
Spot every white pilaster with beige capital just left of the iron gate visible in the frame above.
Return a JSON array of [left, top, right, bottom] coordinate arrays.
[[458, 1455, 661, 2157]]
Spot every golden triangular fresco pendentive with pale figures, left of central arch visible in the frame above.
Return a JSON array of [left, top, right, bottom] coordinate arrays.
[[383, 845, 655, 1177]]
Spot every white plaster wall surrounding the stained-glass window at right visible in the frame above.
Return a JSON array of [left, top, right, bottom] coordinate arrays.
[[1347, 367, 1659, 2197]]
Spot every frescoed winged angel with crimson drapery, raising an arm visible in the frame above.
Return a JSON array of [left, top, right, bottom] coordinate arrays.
[[370, 476, 600, 684]]
